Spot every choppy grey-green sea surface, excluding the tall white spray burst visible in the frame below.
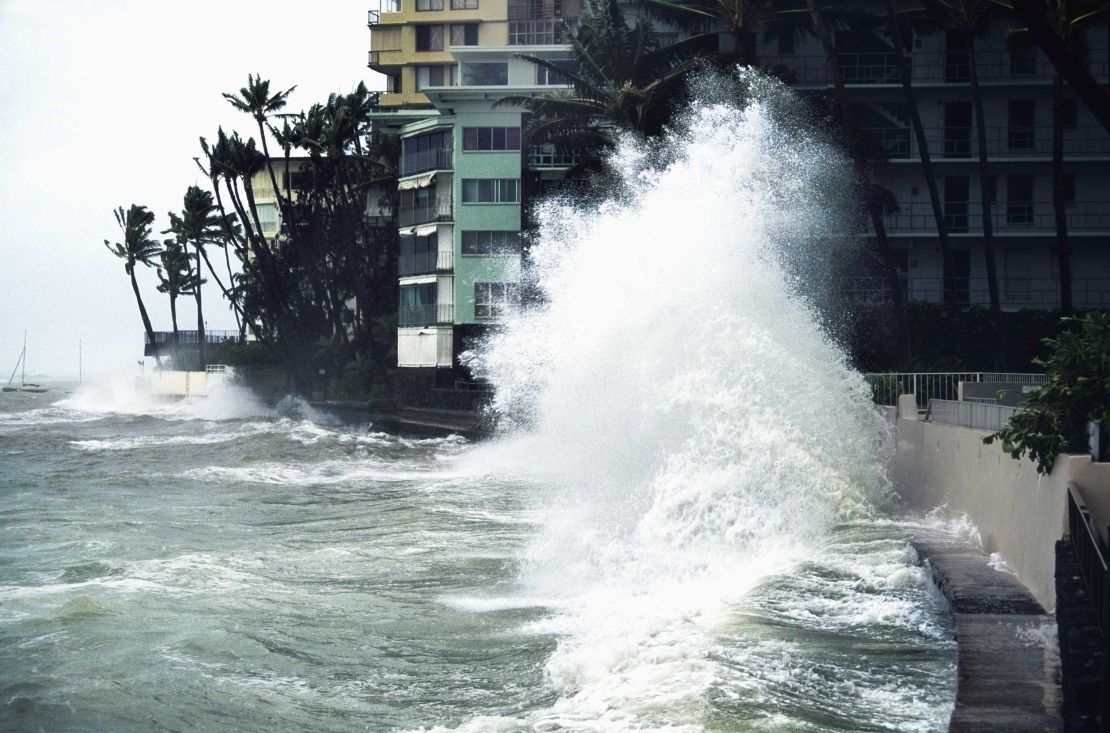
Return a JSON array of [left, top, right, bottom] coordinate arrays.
[[0, 384, 955, 732]]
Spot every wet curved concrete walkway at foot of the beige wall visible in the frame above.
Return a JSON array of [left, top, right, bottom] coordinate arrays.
[[910, 533, 1063, 733]]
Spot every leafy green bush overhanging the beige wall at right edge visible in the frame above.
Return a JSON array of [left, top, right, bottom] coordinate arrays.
[[983, 312, 1110, 473]]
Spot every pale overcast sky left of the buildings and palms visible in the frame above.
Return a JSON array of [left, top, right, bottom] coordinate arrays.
[[0, 0, 382, 382]]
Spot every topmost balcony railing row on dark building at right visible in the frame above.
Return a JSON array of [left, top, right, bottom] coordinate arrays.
[[760, 51, 1108, 87]]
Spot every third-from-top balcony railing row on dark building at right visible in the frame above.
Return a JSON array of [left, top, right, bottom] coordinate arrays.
[[886, 201, 1110, 234]]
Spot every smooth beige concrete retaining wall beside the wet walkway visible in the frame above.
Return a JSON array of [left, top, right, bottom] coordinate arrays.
[[894, 398, 1110, 611]]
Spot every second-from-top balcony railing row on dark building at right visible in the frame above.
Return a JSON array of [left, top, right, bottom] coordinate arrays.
[[862, 125, 1110, 160]]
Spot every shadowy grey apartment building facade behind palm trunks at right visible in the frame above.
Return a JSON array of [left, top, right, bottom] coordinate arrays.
[[759, 10, 1110, 310]]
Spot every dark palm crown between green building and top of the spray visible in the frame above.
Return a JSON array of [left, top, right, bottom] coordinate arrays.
[[498, 0, 704, 149]]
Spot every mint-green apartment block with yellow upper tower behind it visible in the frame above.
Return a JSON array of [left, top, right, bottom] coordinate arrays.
[[370, 0, 579, 402]]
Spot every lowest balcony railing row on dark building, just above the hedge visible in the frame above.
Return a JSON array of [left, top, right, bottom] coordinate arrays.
[[841, 277, 1110, 309]]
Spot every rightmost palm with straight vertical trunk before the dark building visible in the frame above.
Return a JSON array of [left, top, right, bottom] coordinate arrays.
[[999, 0, 1110, 313]]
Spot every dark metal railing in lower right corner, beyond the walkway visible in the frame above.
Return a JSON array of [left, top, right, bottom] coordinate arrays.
[[1068, 483, 1110, 731]]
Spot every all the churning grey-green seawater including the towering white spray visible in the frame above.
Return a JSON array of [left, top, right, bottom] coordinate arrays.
[[0, 70, 955, 733]]
